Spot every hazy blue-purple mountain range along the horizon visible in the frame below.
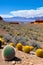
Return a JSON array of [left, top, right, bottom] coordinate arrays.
[[3, 17, 43, 22]]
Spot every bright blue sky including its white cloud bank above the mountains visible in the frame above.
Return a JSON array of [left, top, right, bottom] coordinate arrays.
[[0, 0, 43, 17]]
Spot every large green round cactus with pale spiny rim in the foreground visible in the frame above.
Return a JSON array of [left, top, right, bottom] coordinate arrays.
[[2, 45, 15, 60]]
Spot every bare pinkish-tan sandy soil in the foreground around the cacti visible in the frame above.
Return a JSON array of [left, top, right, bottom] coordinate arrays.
[[0, 45, 43, 65]]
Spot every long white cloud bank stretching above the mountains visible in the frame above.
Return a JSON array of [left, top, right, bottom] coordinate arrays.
[[1, 7, 43, 18]]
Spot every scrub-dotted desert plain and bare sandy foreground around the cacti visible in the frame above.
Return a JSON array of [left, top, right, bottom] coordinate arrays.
[[0, 21, 43, 65]]
